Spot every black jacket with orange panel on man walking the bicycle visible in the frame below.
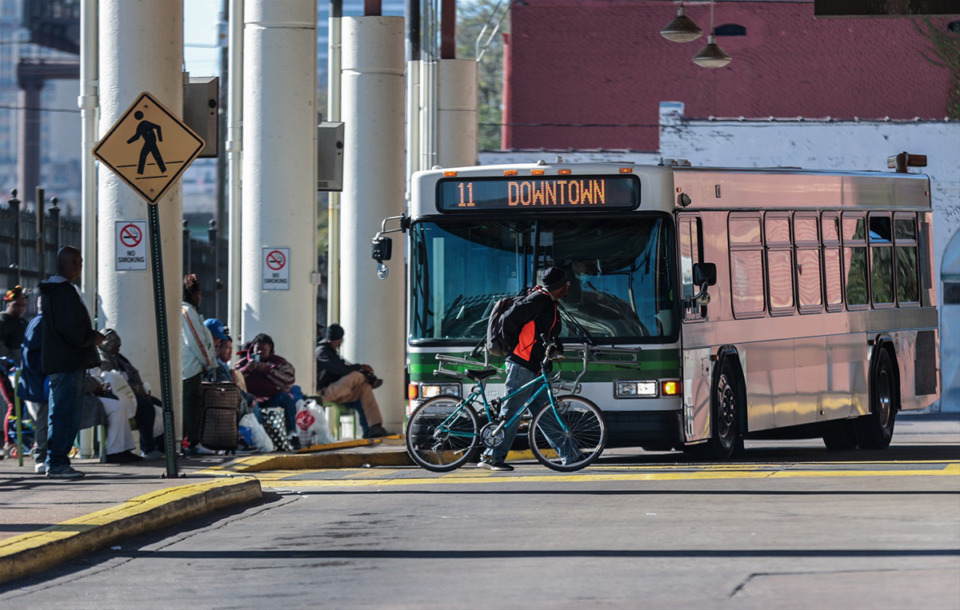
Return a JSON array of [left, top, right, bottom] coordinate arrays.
[[503, 286, 563, 373]]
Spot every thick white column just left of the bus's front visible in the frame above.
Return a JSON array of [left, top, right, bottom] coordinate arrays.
[[342, 17, 406, 431]]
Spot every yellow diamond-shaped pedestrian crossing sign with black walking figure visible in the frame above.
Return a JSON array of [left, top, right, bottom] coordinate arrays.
[[93, 92, 206, 204]]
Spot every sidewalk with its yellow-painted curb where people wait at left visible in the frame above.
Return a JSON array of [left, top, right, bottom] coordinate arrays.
[[0, 437, 410, 583]]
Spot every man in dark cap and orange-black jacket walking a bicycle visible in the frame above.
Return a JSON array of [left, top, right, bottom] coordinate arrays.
[[479, 267, 570, 472]]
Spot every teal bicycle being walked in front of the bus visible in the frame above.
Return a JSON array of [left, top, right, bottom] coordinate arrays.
[[404, 344, 607, 472]]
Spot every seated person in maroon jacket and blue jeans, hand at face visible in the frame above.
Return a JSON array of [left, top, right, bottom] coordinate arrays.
[[234, 333, 300, 449]]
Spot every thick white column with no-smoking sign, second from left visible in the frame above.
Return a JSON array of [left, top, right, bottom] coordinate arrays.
[[241, 0, 317, 393]]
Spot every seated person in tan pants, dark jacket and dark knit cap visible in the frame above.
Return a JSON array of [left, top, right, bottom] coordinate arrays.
[[316, 324, 390, 438]]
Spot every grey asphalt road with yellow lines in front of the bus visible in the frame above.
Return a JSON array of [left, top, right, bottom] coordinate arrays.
[[0, 410, 960, 609]]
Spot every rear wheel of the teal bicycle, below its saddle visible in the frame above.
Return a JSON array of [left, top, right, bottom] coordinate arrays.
[[405, 396, 480, 472]]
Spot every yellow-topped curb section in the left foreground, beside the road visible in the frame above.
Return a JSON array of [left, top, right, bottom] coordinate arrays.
[[0, 477, 262, 582]]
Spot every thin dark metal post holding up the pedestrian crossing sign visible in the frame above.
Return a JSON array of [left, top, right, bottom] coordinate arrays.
[[147, 204, 177, 478]]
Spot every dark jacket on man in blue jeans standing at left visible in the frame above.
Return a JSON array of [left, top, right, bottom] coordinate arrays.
[[39, 281, 100, 375]]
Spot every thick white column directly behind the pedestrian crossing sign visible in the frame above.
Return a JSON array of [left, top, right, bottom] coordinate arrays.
[[98, 0, 185, 438]]
